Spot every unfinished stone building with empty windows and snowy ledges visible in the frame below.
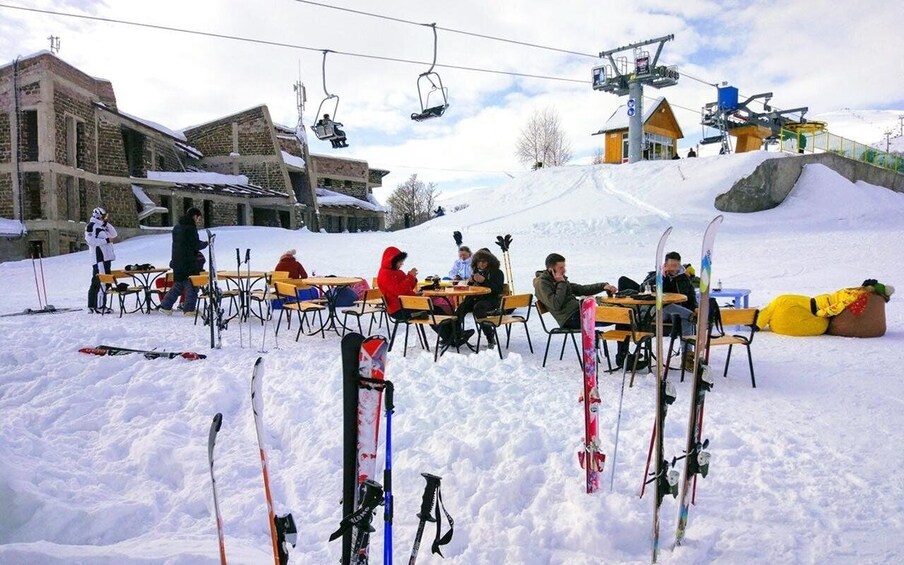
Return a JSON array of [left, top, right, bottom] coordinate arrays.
[[0, 52, 387, 260]]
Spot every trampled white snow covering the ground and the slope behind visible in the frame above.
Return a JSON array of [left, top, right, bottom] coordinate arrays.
[[0, 153, 904, 565]]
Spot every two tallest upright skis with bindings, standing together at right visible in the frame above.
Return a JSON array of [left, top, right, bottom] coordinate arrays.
[[641, 216, 723, 563]]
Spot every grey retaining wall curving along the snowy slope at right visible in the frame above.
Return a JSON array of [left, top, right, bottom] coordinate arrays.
[[715, 153, 904, 212]]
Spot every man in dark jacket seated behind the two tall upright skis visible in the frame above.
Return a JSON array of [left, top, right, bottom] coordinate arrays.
[[615, 251, 697, 366]]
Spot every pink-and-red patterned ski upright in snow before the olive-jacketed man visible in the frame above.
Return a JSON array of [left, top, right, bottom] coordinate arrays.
[[578, 297, 606, 494]]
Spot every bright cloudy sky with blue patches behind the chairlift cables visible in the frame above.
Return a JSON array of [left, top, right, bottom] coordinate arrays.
[[0, 0, 904, 199]]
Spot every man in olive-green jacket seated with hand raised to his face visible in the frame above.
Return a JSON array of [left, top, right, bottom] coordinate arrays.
[[534, 253, 618, 330]]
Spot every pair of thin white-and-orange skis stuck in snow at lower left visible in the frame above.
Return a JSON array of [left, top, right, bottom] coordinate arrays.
[[207, 357, 298, 565]]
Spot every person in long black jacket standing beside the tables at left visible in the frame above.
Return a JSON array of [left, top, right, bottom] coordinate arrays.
[[159, 208, 207, 316]]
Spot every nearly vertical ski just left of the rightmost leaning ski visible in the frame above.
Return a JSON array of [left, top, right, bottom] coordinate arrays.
[[651, 227, 677, 563]]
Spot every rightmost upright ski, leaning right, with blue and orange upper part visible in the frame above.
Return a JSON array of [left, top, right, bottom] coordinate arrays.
[[674, 216, 723, 546]]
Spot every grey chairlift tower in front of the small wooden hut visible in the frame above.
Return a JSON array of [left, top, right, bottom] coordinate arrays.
[[593, 34, 680, 163]]
